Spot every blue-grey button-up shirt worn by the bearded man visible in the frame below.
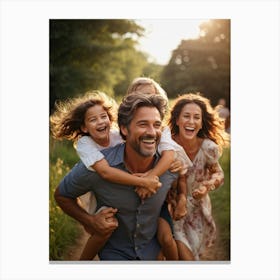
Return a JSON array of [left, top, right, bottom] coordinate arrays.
[[59, 143, 177, 260]]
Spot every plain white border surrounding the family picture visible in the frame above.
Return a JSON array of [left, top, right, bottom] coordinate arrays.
[[0, 0, 280, 280]]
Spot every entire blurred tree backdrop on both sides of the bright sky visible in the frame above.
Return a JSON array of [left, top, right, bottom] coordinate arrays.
[[49, 19, 230, 113]]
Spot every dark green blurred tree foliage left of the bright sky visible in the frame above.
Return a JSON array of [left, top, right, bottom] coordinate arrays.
[[50, 19, 147, 113]]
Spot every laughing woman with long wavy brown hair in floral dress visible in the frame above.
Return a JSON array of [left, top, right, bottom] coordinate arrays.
[[169, 93, 229, 260]]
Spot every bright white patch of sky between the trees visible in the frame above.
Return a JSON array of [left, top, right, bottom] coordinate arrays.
[[136, 19, 208, 65]]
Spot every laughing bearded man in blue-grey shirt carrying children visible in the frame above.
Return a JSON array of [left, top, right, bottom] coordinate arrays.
[[55, 93, 177, 260]]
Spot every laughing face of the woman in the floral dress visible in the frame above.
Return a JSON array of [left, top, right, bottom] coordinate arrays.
[[176, 103, 202, 139]]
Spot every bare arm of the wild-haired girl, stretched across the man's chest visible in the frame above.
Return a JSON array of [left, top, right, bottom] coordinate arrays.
[[91, 159, 161, 193]]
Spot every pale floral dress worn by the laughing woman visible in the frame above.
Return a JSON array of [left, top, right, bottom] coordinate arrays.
[[173, 139, 224, 260]]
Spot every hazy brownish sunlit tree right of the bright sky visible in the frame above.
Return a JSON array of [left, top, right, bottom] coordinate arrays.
[[161, 19, 230, 106]]
